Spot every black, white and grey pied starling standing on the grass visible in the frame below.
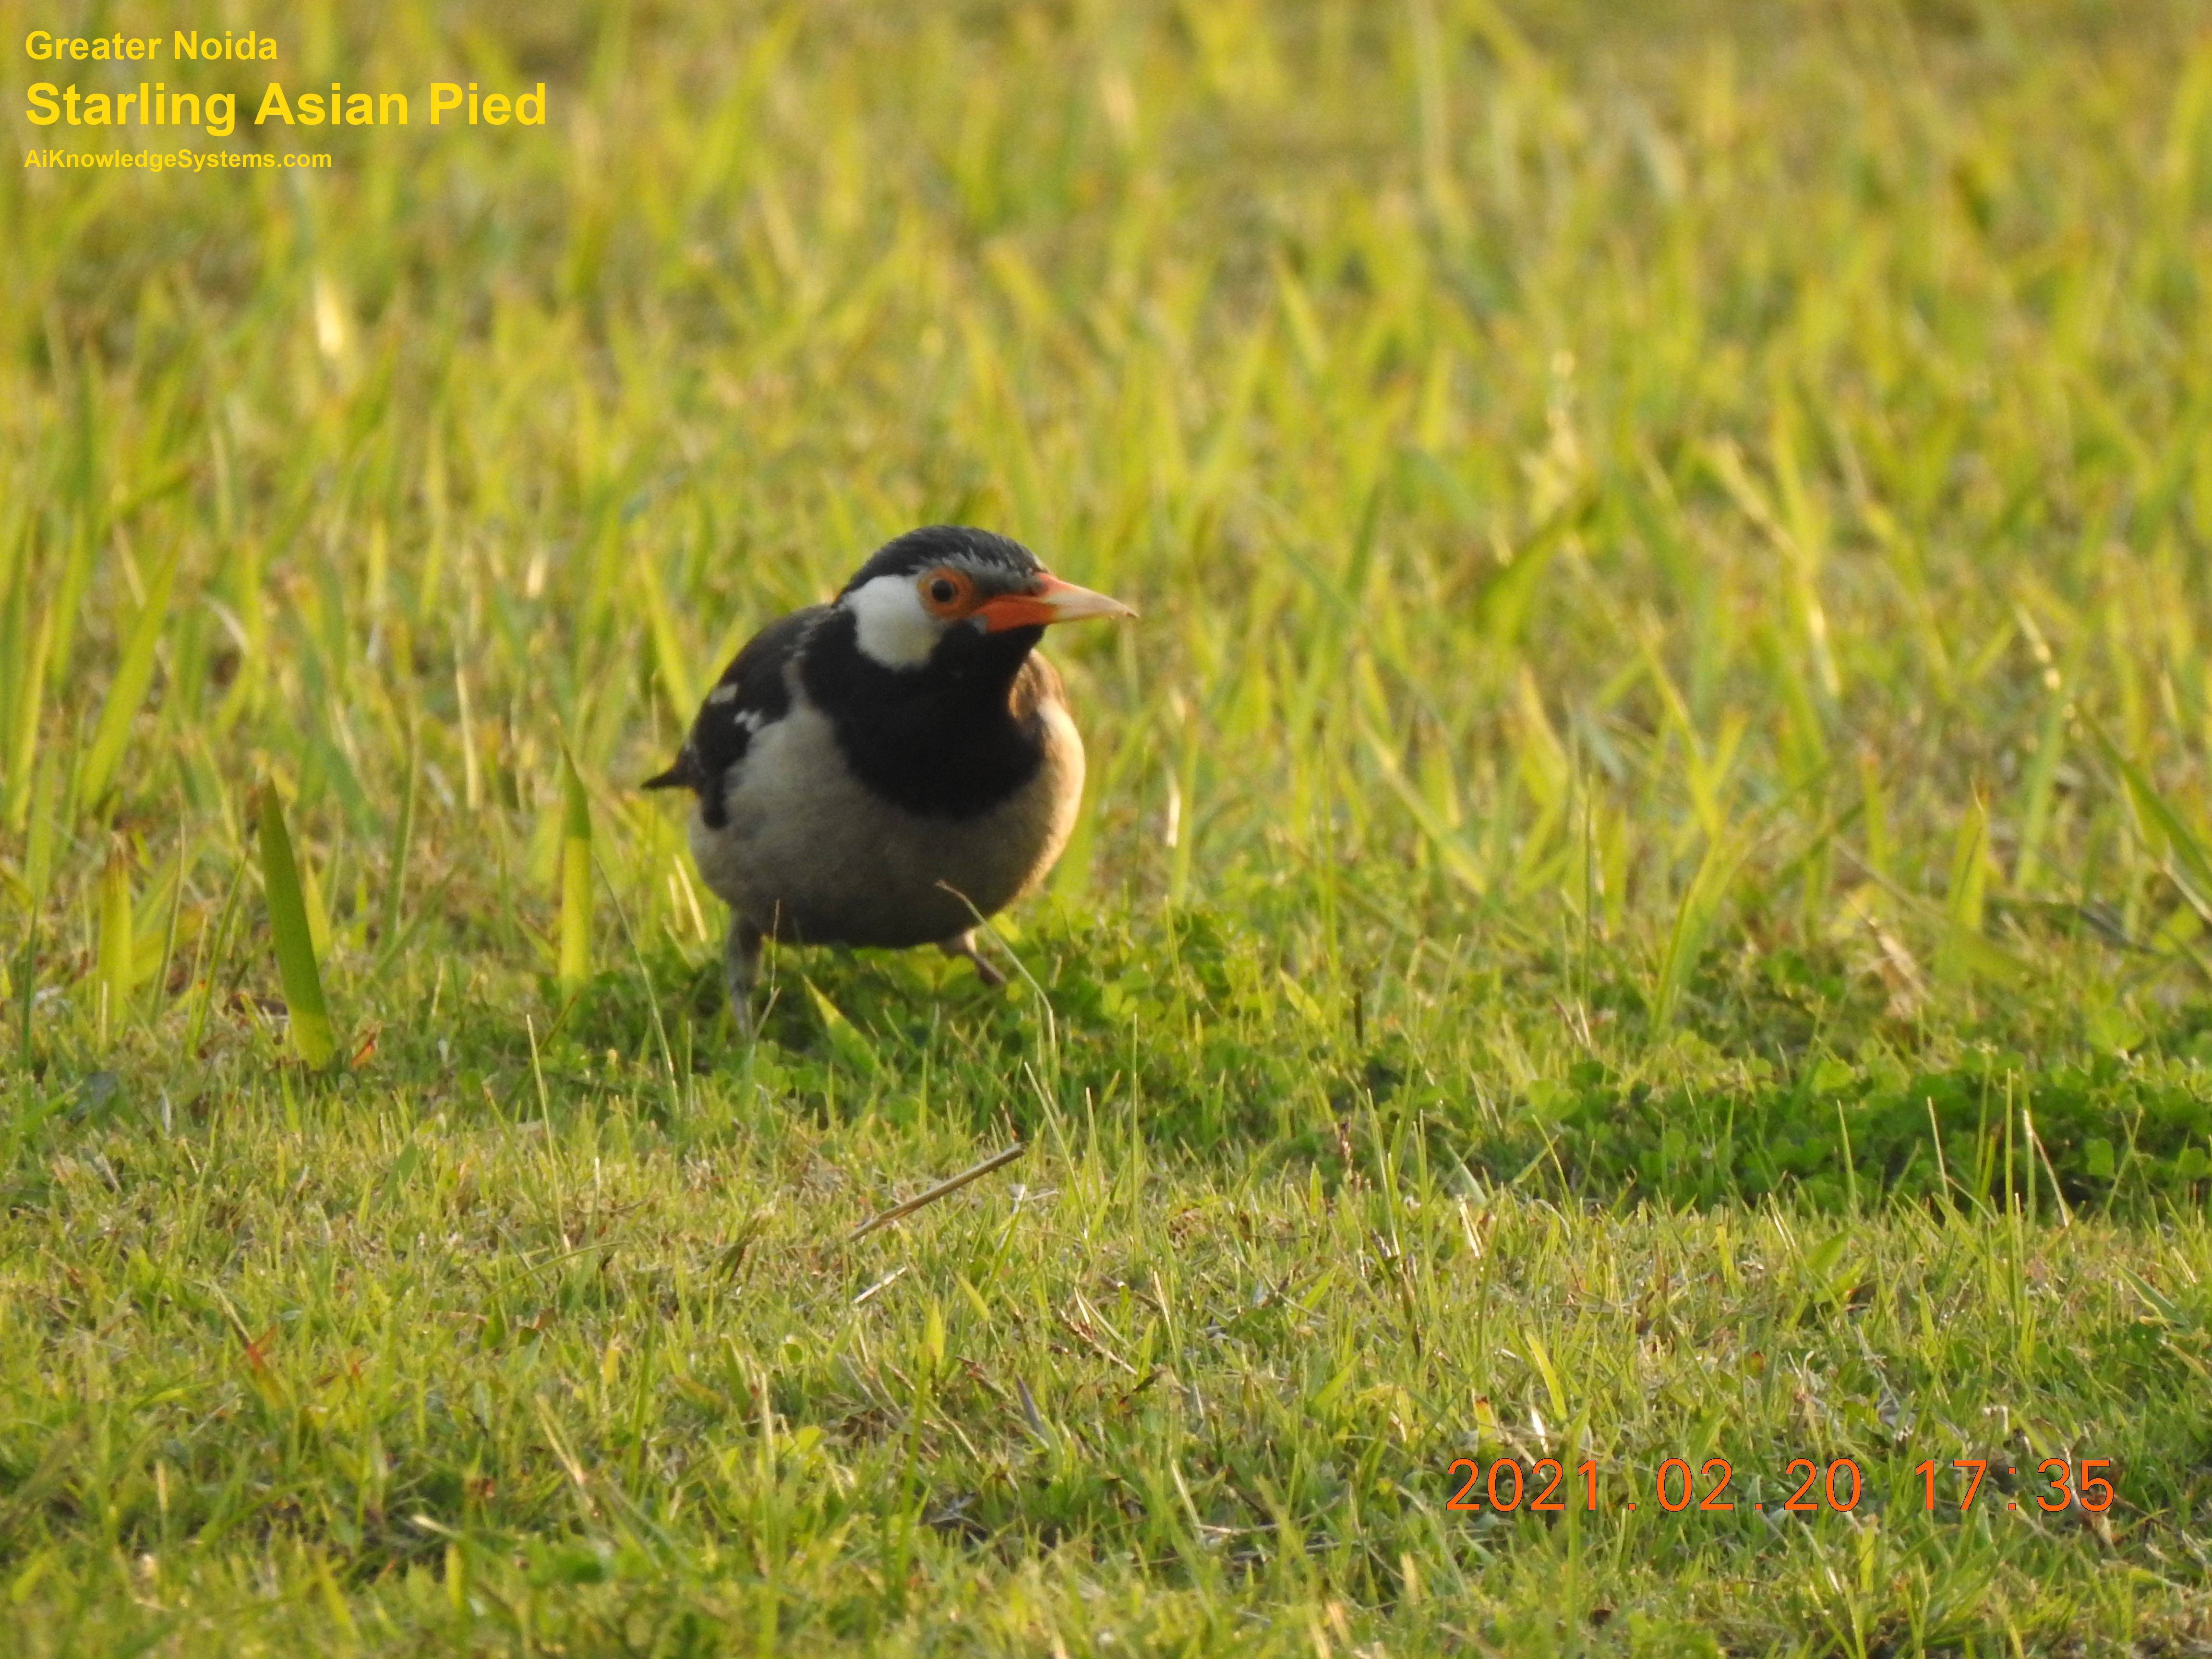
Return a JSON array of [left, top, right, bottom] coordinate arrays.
[[641, 524, 1137, 1033]]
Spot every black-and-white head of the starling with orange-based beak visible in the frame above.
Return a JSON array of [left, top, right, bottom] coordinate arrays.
[[836, 524, 1137, 673]]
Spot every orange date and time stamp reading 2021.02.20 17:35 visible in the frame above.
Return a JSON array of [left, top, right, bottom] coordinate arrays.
[[1444, 1458, 2117, 1515]]
